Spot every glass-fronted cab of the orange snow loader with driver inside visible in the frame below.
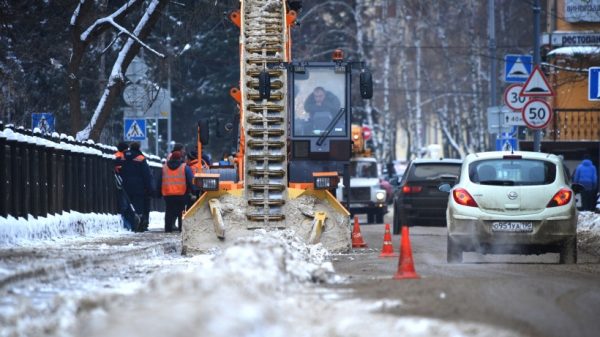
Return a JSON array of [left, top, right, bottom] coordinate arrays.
[[288, 61, 352, 183]]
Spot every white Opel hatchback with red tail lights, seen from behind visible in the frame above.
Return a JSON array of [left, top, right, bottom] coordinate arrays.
[[440, 152, 583, 263]]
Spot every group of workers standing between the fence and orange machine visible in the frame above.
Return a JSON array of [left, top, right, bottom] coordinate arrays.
[[115, 142, 220, 233]]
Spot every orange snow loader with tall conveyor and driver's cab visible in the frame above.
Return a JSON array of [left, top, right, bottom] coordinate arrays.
[[182, 0, 372, 253]]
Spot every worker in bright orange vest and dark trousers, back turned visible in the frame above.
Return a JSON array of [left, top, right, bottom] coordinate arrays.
[[160, 151, 194, 233]]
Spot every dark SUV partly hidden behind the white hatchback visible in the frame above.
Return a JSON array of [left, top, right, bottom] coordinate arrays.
[[393, 159, 462, 234]]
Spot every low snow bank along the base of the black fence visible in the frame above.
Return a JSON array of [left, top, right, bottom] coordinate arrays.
[[0, 211, 126, 247]]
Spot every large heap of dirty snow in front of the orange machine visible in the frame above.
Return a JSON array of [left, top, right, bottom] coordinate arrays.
[[68, 231, 515, 337]]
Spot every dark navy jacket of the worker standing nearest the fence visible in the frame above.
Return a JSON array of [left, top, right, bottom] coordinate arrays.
[[121, 150, 152, 197]]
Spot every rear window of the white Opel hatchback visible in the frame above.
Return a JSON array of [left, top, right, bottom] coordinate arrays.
[[469, 159, 556, 186]]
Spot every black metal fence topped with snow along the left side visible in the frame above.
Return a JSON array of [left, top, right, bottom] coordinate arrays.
[[0, 123, 164, 218]]
